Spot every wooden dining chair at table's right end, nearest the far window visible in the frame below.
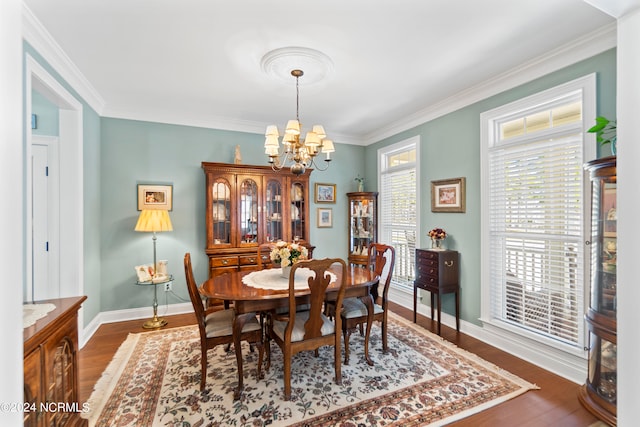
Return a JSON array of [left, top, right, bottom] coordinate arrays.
[[340, 243, 396, 365]]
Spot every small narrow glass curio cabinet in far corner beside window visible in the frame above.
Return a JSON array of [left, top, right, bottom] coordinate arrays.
[[347, 192, 378, 265]]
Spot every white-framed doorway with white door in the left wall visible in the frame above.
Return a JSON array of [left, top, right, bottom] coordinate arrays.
[[23, 54, 84, 301]]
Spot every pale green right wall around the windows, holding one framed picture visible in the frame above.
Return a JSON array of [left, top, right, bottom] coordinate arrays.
[[365, 49, 616, 324]]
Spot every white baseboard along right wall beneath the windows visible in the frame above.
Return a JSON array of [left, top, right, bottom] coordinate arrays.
[[389, 289, 587, 384]]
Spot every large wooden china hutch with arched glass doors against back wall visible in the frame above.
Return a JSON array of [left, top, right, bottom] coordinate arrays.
[[202, 162, 313, 277]]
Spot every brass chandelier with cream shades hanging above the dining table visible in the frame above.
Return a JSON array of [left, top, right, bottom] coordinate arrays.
[[264, 70, 336, 175]]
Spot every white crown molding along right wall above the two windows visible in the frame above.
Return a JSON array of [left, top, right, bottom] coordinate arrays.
[[364, 22, 617, 145]]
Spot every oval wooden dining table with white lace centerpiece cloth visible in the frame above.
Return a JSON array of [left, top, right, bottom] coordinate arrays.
[[199, 265, 379, 400]]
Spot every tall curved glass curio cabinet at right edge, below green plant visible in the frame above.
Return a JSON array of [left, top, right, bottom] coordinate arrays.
[[578, 156, 618, 425]]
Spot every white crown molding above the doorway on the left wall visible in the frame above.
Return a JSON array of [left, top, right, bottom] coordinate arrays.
[[22, 3, 105, 115]]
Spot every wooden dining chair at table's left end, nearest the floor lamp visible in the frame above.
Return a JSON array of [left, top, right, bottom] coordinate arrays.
[[184, 252, 264, 399]]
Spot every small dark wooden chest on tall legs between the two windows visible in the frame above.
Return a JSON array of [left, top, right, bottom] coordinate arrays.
[[413, 249, 460, 335]]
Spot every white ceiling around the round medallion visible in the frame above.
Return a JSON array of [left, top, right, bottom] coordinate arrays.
[[24, 0, 615, 144]]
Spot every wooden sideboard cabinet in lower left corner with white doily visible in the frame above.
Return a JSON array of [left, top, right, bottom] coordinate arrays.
[[24, 296, 87, 427]]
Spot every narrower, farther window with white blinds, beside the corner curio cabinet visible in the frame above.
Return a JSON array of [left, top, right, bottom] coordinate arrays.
[[378, 137, 420, 290]]
